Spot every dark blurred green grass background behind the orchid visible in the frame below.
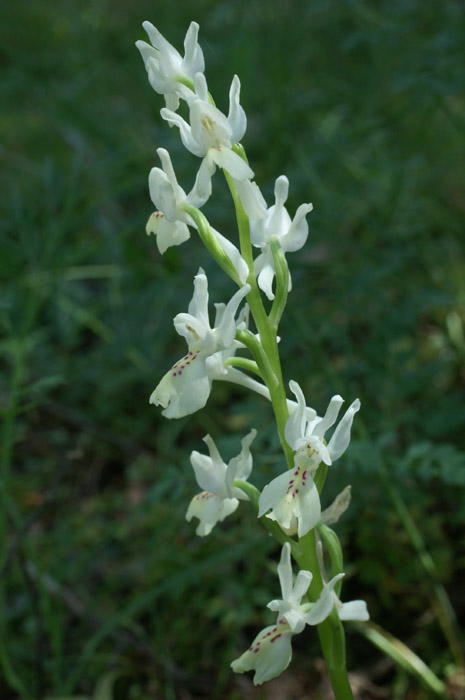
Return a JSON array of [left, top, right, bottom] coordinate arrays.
[[0, 0, 465, 700]]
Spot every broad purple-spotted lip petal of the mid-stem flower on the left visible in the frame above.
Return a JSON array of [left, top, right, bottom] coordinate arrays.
[[150, 354, 211, 418]]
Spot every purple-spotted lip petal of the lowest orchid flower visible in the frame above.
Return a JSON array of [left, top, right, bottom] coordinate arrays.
[[231, 621, 292, 685]]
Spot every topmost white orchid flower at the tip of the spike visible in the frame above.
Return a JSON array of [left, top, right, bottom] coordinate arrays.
[[136, 22, 205, 109]]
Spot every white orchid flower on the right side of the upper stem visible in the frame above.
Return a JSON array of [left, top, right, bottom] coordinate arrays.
[[236, 175, 313, 299]]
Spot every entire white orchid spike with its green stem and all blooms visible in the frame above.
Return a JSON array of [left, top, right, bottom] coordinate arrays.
[[136, 22, 368, 698]]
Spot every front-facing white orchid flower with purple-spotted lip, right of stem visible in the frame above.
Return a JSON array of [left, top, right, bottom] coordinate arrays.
[[258, 381, 360, 537]]
